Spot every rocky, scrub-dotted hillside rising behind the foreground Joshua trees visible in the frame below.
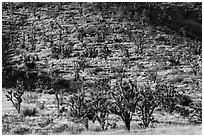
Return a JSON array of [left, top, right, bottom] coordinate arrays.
[[2, 3, 202, 135]]
